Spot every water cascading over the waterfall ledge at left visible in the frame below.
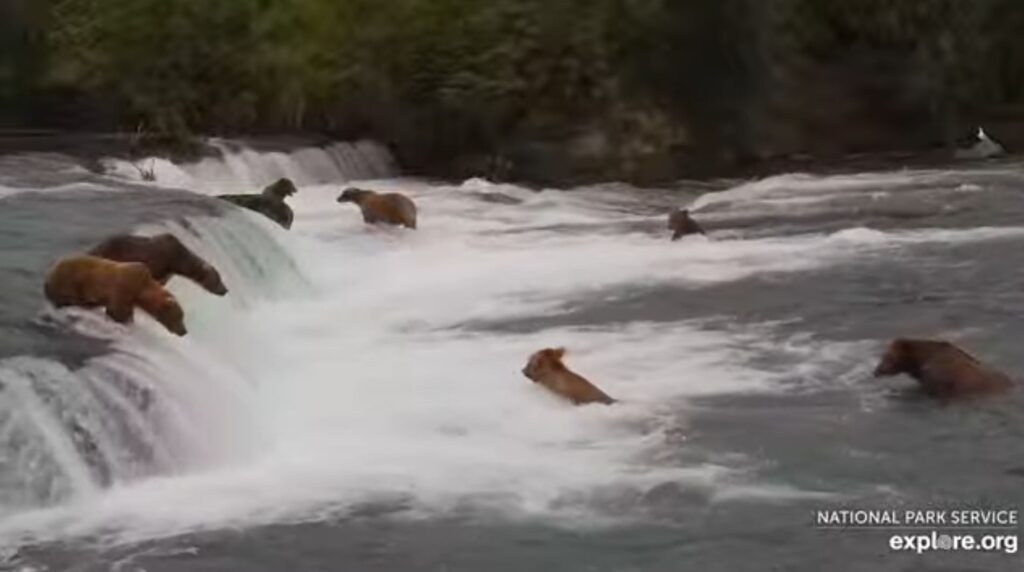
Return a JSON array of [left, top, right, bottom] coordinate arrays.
[[0, 141, 393, 515]]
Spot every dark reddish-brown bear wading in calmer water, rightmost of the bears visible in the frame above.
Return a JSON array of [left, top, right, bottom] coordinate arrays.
[[874, 338, 1013, 400]]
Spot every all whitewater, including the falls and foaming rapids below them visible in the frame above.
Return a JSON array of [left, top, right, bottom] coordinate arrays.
[[0, 143, 1024, 545]]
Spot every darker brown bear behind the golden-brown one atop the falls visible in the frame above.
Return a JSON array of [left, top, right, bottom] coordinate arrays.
[[89, 234, 227, 296]]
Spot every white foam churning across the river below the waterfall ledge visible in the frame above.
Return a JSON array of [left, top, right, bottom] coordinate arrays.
[[0, 166, 1024, 543]]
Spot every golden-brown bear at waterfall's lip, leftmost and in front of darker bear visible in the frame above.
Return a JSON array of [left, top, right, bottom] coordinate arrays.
[[44, 255, 186, 336]]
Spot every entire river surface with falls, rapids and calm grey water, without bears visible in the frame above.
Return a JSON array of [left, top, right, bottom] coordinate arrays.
[[0, 141, 1024, 572]]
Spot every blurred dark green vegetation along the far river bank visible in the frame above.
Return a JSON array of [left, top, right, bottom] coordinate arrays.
[[0, 0, 1024, 181]]
